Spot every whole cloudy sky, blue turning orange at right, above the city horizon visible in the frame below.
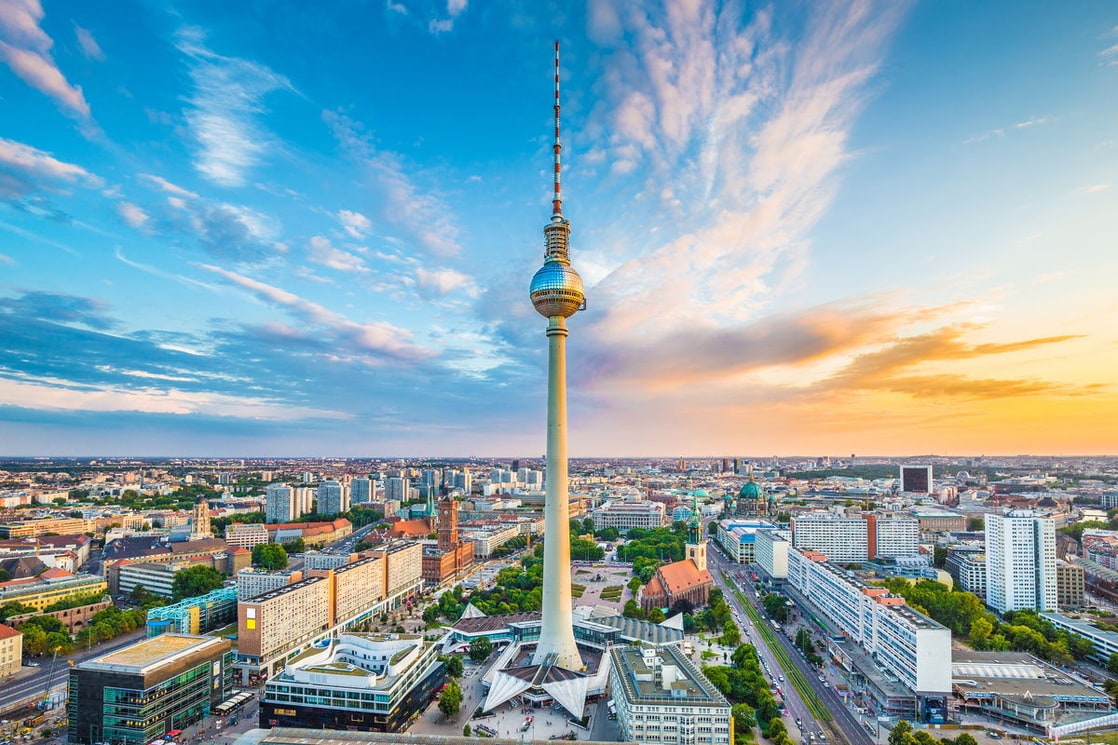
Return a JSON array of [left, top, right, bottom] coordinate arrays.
[[0, 0, 1118, 456]]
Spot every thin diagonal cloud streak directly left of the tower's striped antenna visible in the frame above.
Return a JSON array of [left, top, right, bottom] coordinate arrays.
[[322, 111, 461, 256]]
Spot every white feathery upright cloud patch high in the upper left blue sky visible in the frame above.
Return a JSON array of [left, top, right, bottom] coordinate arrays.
[[178, 28, 294, 187]]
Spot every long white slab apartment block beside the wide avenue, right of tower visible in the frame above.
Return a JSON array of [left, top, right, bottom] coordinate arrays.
[[788, 549, 951, 698]]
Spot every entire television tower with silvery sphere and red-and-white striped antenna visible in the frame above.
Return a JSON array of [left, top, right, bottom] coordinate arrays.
[[529, 41, 586, 670]]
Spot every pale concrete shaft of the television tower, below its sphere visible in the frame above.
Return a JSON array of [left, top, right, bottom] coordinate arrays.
[[532, 315, 582, 670]]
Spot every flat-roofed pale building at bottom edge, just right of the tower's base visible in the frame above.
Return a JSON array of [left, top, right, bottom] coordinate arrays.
[[609, 645, 733, 745]]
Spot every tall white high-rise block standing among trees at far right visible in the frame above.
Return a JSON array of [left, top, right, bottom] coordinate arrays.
[[986, 510, 1058, 613]]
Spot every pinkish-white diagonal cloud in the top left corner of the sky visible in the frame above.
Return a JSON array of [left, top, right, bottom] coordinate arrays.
[[0, 0, 89, 119]]
